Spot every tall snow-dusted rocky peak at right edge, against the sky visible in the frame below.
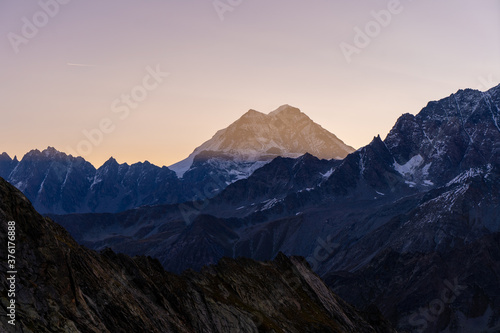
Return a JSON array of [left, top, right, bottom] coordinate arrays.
[[385, 86, 500, 185]]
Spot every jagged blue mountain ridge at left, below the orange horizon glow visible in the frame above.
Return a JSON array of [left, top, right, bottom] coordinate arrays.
[[0, 147, 184, 213]]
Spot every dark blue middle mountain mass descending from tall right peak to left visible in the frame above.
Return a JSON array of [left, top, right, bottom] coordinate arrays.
[[55, 82, 500, 332]]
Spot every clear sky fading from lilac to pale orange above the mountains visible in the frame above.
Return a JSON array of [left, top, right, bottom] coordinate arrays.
[[0, 0, 500, 167]]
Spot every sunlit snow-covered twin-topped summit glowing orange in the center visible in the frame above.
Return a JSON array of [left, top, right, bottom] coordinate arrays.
[[169, 105, 354, 177]]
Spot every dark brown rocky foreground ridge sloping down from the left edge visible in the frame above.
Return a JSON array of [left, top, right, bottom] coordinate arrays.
[[0, 179, 394, 333]]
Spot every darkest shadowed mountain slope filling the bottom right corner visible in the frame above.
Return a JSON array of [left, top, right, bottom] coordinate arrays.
[[324, 232, 500, 333]]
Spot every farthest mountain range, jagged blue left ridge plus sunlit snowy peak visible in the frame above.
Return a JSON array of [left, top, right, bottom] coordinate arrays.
[[0, 106, 354, 214]]
